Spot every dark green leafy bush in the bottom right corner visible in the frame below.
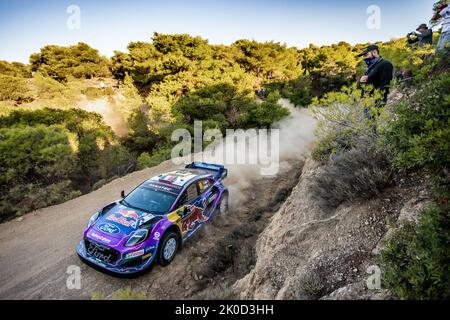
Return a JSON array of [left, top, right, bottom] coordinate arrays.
[[379, 206, 450, 300]]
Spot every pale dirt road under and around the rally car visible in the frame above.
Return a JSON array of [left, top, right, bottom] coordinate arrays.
[[0, 161, 301, 299]]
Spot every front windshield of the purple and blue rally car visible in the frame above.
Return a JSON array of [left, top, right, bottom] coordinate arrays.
[[122, 186, 176, 214]]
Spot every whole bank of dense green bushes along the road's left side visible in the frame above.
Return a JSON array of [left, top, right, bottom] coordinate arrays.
[[0, 109, 134, 221]]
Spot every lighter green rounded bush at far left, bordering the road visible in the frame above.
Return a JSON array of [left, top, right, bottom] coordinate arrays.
[[0, 125, 74, 220]]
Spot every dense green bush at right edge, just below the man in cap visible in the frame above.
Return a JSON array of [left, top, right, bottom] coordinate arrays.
[[384, 72, 450, 172]]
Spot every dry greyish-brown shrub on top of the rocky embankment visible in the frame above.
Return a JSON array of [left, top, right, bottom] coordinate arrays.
[[310, 145, 391, 208]]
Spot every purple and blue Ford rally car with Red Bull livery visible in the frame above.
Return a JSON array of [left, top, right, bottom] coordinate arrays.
[[77, 162, 228, 274]]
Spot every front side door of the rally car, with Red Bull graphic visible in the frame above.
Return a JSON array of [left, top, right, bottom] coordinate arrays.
[[178, 182, 208, 238]]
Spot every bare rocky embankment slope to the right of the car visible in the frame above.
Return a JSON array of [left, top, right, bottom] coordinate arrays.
[[233, 159, 430, 299]]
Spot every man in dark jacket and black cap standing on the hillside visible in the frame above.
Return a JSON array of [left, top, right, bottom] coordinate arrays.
[[358, 45, 394, 108]]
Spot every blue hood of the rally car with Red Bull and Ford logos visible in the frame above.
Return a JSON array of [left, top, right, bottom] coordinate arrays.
[[92, 203, 161, 238]]
